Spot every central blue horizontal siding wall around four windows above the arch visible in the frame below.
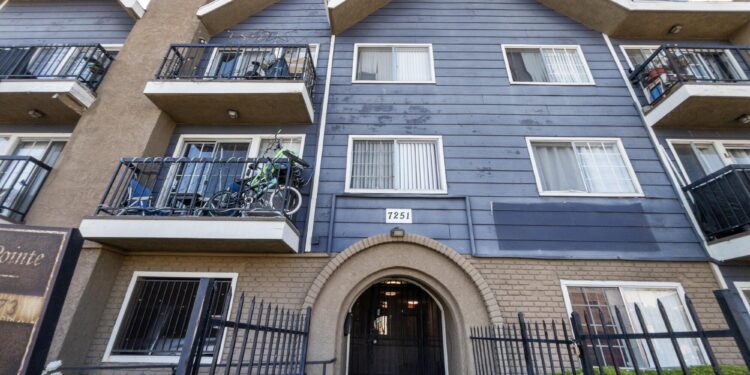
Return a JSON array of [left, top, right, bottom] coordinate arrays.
[[313, 0, 705, 260]]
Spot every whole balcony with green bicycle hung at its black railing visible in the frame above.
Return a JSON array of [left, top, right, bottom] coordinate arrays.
[[81, 153, 314, 253]]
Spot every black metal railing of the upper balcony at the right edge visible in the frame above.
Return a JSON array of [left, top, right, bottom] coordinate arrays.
[[630, 45, 750, 110]]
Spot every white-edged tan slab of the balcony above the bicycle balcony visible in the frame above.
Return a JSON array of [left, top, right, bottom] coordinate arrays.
[[144, 80, 314, 124]]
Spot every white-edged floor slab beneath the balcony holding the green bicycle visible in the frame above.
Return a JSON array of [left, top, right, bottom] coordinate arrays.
[[80, 216, 299, 253]]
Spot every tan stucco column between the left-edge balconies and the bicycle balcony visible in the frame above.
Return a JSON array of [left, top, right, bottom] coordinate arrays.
[[26, 0, 206, 227]]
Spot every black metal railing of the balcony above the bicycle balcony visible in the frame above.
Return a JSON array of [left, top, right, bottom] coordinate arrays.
[[156, 44, 315, 94]]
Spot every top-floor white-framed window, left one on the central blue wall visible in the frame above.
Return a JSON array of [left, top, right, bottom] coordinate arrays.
[[352, 44, 435, 83]]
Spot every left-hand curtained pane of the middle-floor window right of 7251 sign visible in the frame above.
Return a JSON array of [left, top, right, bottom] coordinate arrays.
[[533, 142, 586, 192]]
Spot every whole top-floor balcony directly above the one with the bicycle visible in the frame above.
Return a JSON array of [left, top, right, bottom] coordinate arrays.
[[144, 44, 315, 124]]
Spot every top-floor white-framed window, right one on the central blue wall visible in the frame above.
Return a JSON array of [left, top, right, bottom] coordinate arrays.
[[503, 45, 594, 85]]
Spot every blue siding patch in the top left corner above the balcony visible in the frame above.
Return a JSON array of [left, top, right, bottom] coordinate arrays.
[[0, 0, 134, 46]]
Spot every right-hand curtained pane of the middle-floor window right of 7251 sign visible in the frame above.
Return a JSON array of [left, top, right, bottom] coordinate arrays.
[[575, 142, 635, 193]]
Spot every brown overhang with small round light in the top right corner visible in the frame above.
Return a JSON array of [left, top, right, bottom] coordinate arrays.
[[538, 0, 750, 40]]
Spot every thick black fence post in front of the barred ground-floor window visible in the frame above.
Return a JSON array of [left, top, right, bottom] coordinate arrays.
[[176, 278, 213, 375]]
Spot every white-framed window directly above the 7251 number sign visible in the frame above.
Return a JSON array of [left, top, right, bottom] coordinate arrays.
[[346, 137, 447, 193]]
